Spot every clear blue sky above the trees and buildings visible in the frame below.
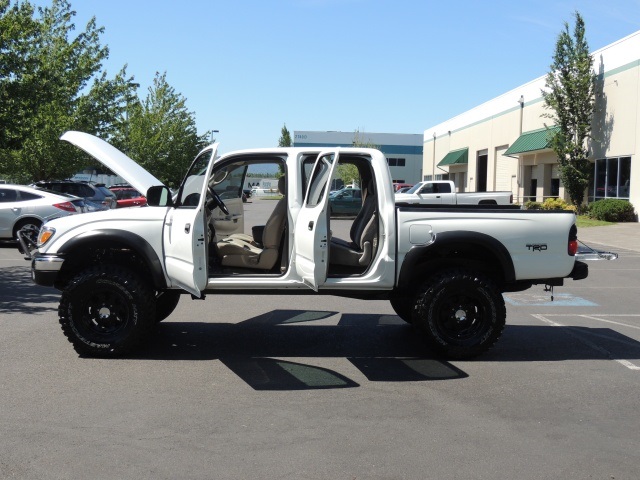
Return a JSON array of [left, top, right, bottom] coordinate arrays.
[[32, 0, 640, 152]]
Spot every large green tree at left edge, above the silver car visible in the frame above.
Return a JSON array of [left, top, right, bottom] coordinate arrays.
[[0, 0, 137, 182]]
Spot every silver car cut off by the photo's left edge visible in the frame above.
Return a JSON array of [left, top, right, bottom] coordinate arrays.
[[0, 185, 86, 242]]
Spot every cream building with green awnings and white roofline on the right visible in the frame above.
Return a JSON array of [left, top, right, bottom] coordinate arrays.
[[423, 31, 640, 211]]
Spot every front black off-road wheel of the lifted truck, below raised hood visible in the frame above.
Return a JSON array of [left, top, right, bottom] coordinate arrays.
[[58, 265, 156, 357]]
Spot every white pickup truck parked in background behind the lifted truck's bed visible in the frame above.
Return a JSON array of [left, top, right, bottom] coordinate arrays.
[[395, 180, 513, 205]]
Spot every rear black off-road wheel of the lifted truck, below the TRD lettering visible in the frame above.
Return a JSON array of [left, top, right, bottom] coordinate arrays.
[[413, 269, 506, 359]]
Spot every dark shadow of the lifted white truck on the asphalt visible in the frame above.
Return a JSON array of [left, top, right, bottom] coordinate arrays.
[[132, 310, 640, 390]]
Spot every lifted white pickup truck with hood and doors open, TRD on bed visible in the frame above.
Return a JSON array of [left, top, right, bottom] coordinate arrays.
[[27, 132, 588, 358]]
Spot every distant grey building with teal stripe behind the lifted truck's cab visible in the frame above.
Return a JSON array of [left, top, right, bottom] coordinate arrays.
[[293, 131, 423, 183]]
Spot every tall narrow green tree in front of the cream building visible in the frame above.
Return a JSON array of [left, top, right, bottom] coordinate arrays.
[[542, 12, 596, 212]]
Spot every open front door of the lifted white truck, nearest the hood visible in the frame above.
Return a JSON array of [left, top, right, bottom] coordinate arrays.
[[163, 144, 218, 297]]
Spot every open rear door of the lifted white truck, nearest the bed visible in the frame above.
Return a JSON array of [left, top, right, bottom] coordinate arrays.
[[294, 150, 340, 291]]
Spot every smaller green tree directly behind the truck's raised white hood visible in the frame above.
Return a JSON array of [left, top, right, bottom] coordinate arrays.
[[114, 73, 211, 187]]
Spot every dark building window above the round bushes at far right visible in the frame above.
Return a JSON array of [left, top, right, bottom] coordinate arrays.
[[589, 157, 631, 201]]
